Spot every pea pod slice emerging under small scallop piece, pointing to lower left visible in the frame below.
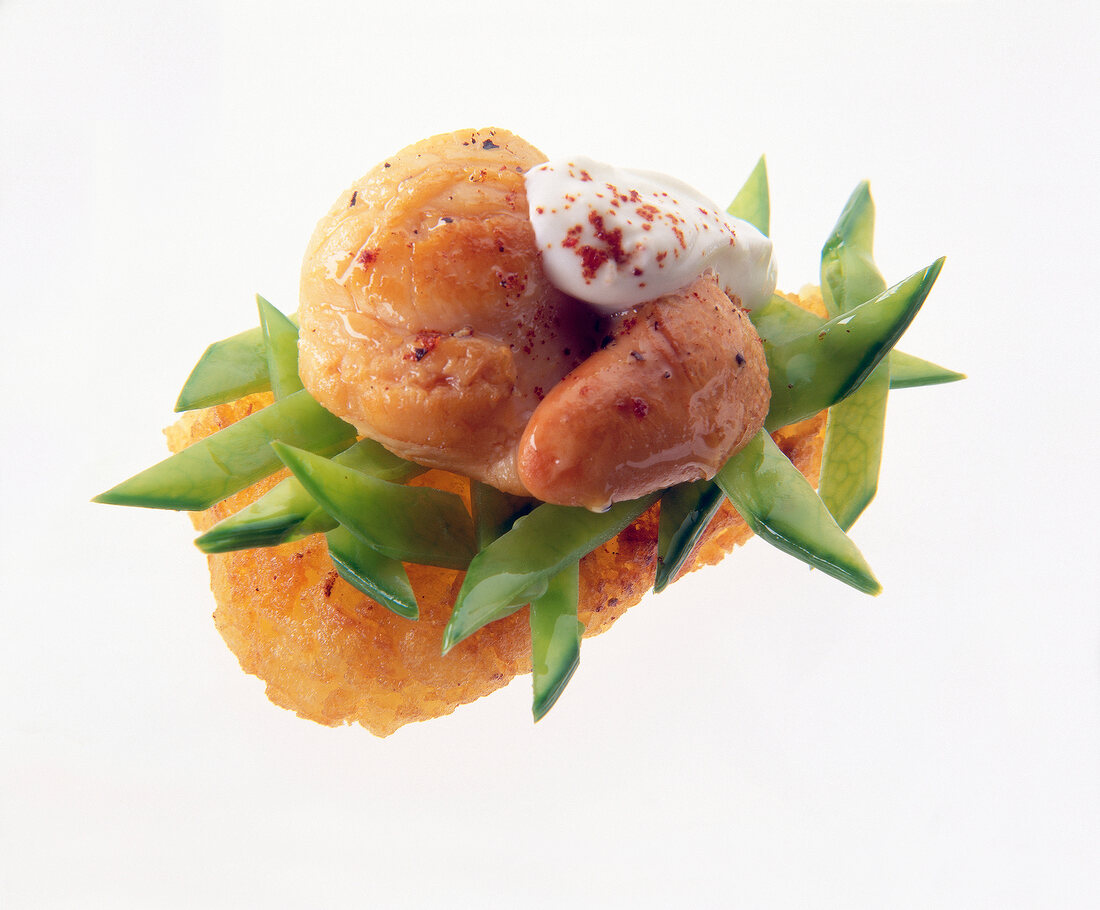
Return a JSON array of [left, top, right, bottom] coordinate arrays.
[[443, 493, 657, 654]]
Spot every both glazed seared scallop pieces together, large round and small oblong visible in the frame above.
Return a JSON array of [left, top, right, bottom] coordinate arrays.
[[299, 130, 769, 509]]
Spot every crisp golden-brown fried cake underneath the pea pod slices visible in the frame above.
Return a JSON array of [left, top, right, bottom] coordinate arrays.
[[166, 288, 825, 736]]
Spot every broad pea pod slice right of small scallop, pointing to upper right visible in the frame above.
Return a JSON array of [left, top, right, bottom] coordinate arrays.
[[765, 259, 944, 430]]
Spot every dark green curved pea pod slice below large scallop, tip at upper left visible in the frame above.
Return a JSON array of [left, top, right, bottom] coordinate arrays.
[[273, 442, 475, 569]]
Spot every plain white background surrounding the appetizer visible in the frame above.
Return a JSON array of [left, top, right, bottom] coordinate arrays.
[[0, 0, 1100, 908]]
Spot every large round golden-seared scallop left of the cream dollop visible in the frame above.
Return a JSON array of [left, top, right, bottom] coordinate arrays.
[[299, 130, 598, 494]]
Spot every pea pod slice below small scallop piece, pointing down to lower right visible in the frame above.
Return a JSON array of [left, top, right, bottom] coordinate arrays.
[[715, 430, 882, 594]]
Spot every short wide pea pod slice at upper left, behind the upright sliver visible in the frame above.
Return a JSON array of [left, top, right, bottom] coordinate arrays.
[[176, 316, 297, 412]]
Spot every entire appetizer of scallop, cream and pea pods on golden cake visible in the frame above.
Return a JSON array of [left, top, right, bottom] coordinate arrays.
[[97, 130, 961, 735]]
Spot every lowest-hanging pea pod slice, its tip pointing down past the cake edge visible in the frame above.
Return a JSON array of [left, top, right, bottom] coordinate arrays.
[[530, 562, 584, 721]]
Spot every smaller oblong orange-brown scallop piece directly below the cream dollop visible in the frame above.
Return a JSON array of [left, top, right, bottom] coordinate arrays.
[[518, 275, 771, 509]]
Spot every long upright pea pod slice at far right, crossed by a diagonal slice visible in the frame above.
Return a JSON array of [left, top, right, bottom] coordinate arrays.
[[817, 180, 890, 530]]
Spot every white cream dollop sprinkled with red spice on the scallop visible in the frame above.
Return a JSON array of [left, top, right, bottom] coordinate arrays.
[[526, 157, 776, 315]]
